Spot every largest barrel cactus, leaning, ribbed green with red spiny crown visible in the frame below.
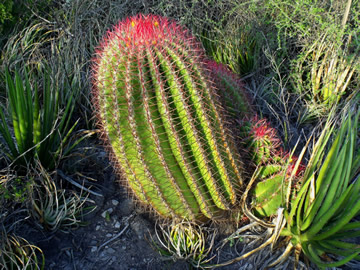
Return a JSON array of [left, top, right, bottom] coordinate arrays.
[[93, 15, 242, 220]]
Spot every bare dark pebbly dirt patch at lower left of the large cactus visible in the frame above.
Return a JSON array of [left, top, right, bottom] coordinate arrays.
[[13, 142, 248, 270]]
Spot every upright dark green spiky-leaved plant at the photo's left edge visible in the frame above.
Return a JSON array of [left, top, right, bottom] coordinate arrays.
[[0, 67, 77, 169]]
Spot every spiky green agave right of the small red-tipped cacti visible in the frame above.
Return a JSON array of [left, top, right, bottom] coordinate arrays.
[[272, 112, 360, 268]]
